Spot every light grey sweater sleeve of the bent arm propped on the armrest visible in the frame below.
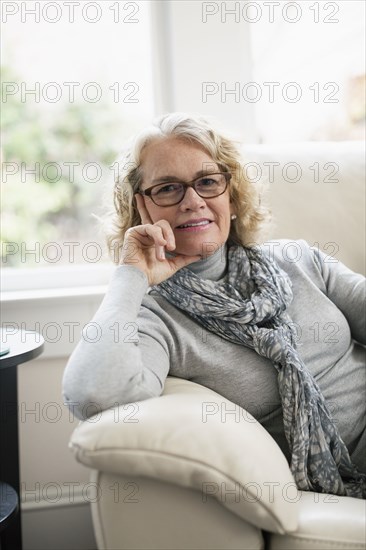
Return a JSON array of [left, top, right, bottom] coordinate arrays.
[[62, 266, 169, 419]]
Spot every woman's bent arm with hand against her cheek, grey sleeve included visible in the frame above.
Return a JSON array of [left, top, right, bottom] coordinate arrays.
[[63, 195, 200, 418]]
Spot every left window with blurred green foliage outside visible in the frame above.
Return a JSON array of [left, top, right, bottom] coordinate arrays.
[[1, 2, 154, 277]]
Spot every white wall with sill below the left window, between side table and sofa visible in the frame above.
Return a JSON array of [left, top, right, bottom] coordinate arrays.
[[2, 287, 104, 550]]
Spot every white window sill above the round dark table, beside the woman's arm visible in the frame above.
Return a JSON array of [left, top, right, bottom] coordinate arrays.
[[1, 265, 115, 361]]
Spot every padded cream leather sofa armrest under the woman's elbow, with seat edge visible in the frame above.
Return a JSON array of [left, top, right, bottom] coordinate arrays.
[[70, 378, 366, 550]]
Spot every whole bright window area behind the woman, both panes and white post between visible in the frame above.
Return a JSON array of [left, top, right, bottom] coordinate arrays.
[[2, 0, 365, 288]]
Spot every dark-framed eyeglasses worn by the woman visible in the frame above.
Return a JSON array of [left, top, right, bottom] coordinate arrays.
[[138, 172, 231, 206]]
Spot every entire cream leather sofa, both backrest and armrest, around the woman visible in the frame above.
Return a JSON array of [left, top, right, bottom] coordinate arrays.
[[70, 142, 366, 550]]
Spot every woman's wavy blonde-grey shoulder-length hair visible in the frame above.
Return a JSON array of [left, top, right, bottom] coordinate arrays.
[[106, 113, 269, 263]]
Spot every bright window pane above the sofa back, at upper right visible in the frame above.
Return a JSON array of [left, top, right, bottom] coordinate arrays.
[[250, 0, 365, 143]]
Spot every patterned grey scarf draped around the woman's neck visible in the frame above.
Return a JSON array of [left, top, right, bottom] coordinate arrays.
[[153, 245, 366, 498]]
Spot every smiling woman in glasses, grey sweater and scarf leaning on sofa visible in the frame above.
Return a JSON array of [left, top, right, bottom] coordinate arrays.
[[63, 113, 366, 498]]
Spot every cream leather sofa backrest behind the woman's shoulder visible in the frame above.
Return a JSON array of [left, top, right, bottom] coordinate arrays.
[[243, 141, 366, 274]]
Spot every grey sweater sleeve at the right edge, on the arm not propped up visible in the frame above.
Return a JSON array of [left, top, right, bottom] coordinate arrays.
[[311, 248, 366, 344]]
